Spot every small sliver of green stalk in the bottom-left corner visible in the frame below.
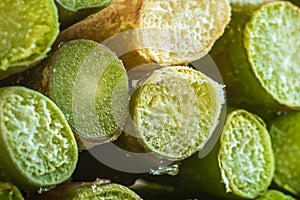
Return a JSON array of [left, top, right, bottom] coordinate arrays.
[[0, 182, 24, 200]]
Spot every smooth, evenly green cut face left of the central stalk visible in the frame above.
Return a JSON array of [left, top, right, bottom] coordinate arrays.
[[47, 40, 128, 144]]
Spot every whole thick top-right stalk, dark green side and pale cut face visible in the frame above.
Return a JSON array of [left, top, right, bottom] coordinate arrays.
[[212, 1, 300, 112]]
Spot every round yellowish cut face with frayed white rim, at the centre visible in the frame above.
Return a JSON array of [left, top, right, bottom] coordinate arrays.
[[131, 66, 224, 160]]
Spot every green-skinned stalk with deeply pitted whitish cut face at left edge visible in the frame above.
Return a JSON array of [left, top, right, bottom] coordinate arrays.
[[0, 86, 78, 190]]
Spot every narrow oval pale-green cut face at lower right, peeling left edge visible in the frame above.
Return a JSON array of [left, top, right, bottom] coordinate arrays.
[[218, 110, 274, 198]]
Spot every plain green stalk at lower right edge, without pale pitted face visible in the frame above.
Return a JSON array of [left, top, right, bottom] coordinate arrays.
[[270, 112, 300, 196]]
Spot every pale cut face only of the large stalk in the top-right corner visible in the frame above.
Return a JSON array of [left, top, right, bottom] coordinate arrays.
[[244, 1, 300, 107]]
